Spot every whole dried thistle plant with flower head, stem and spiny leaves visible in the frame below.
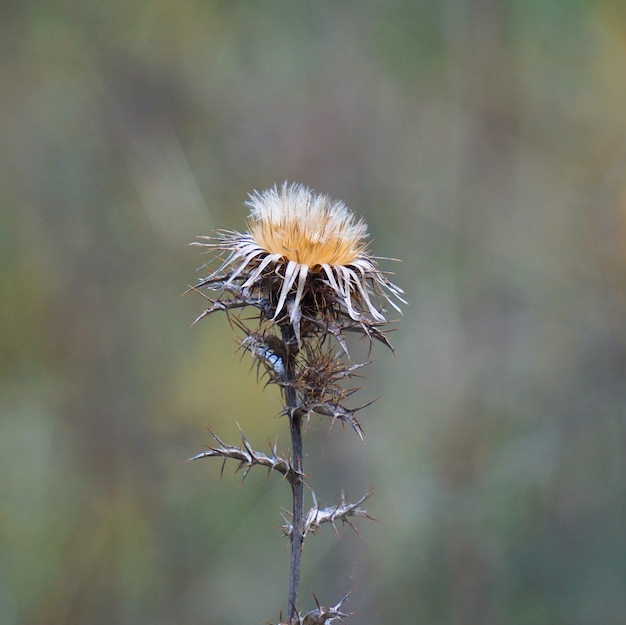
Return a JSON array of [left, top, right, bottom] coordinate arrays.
[[185, 183, 404, 625]]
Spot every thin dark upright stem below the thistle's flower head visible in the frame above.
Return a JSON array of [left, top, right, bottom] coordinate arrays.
[[280, 324, 304, 623]]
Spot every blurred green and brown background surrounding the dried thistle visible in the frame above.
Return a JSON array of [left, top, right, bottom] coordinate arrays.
[[0, 0, 626, 625]]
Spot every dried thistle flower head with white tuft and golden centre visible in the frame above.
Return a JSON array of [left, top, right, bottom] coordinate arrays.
[[191, 182, 404, 341]]
